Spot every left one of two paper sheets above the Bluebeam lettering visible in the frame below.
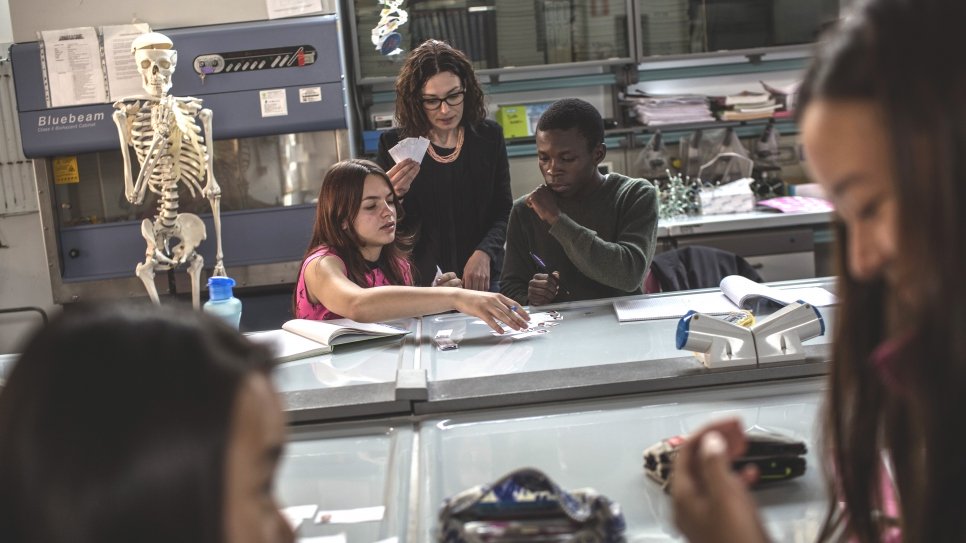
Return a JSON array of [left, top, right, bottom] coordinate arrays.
[[40, 26, 107, 107]]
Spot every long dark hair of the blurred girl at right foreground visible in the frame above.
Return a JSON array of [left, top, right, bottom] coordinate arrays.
[[799, 0, 966, 542]]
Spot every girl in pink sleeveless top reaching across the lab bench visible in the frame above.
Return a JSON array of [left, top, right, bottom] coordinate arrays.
[[292, 160, 529, 332]]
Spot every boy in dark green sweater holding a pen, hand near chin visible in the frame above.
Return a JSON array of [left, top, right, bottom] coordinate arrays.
[[500, 98, 658, 305]]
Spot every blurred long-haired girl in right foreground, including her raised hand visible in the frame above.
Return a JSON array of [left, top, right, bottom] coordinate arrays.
[[671, 0, 966, 543]]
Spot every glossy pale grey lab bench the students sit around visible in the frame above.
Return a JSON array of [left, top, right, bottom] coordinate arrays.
[[262, 279, 835, 543]]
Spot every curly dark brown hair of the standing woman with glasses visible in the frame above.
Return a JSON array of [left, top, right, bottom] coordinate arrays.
[[396, 40, 486, 138]]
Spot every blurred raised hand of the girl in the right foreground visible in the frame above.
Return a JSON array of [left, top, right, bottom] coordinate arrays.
[[671, 419, 768, 543]]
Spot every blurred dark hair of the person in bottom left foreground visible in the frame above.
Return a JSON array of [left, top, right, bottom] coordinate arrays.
[[0, 305, 271, 543]]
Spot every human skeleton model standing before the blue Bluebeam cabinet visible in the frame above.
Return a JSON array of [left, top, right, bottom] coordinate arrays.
[[114, 32, 225, 309]]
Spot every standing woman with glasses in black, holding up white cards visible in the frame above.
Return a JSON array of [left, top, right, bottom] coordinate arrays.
[[377, 40, 513, 291]]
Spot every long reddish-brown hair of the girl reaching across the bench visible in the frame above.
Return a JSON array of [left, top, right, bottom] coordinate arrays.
[[292, 159, 412, 315]]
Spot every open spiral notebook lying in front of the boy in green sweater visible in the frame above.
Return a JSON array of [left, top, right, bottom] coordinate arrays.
[[614, 275, 836, 322]]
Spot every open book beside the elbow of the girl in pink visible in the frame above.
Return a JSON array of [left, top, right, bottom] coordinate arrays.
[[248, 319, 409, 363]]
